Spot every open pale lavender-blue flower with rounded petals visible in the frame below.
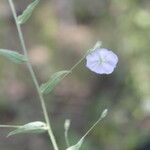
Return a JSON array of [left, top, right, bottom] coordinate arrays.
[[86, 48, 118, 74]]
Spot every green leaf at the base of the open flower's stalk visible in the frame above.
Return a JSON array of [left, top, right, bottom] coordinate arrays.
[[40, 70, 71, 94]]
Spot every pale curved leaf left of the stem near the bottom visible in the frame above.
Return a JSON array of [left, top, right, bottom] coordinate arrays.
[[7, 121, 47, 137]]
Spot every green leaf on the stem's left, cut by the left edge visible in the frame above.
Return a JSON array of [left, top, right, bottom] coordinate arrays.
[[0, 49, 27, 63]]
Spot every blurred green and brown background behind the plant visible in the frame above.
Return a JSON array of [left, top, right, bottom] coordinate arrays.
[[0, 0, 150, 150]]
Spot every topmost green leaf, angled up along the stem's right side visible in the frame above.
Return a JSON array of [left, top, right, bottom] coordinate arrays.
[[17, 0, 40, 25]]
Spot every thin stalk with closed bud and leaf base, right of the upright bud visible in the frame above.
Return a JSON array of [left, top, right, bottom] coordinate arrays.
[[66, 109, 108, 150]]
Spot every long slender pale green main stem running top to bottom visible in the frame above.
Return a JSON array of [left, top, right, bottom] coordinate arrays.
[[8, 0, 59, 150]]
